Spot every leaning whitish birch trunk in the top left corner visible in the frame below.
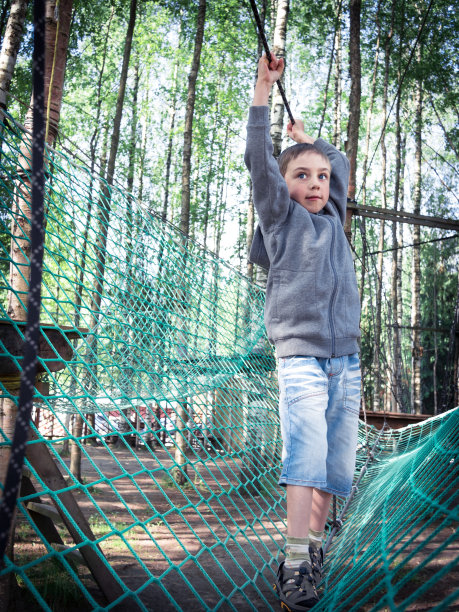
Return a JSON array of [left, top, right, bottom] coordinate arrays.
[[0, 0, 29, 109]]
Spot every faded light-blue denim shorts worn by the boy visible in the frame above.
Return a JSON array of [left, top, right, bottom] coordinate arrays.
[[278, 353, 360, 496]]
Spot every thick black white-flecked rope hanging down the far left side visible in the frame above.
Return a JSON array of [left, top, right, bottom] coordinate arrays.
[[0, 0, 45, 565]]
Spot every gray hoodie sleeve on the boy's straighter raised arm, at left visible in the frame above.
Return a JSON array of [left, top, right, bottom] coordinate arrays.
[[244, 106, 290, 231]]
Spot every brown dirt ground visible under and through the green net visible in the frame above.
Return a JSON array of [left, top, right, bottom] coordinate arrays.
[[7, 446, 459, 612]]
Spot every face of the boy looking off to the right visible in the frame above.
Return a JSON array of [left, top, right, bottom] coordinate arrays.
[[285, 151, 331, 213]]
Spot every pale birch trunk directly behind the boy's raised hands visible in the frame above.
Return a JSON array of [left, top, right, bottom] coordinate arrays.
[[271, 0, 289, 157]]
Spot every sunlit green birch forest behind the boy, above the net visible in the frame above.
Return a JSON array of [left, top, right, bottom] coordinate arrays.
[[0, 0, 459, 414]]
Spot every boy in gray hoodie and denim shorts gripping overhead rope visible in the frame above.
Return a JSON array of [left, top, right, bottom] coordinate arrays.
[[245, 56, 360, 610]]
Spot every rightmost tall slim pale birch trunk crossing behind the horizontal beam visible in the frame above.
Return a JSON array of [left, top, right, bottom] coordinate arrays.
[[411, 47, 423, 414]]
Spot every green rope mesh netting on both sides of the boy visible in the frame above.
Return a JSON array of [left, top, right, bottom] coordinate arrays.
[[0, 113, 459, 611]]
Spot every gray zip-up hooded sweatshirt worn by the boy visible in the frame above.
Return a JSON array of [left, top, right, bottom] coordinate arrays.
[[244, 106, 360, 358]]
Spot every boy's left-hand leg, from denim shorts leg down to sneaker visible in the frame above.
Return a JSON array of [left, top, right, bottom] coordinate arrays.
[[276, 357, 328, 610]]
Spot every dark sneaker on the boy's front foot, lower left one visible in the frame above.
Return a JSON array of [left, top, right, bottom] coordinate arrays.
[[274, 561, 319, 612]]
